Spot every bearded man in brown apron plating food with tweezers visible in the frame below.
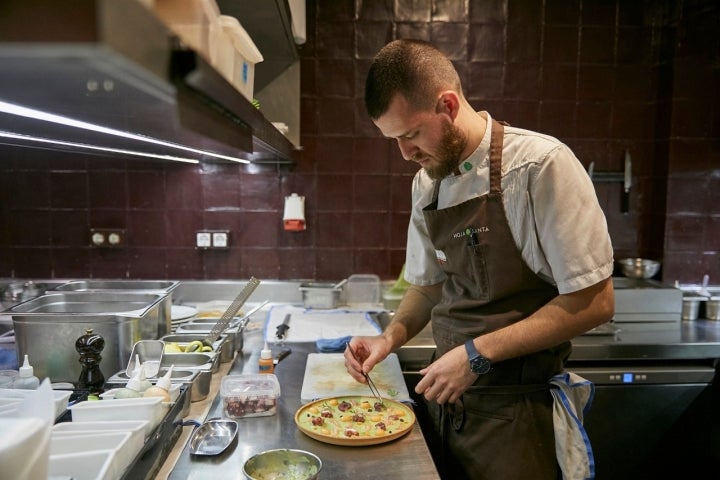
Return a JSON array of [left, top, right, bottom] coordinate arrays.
[[345, 40, 614, 480]]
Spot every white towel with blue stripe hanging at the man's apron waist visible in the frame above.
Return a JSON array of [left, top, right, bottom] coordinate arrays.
[[550, 372, 595, 480]]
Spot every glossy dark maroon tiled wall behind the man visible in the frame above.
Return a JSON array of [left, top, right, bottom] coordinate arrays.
[[0, 0, 720, 283]]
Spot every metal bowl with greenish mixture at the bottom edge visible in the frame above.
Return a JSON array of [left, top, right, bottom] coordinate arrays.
[[243, 448, 322, 480]]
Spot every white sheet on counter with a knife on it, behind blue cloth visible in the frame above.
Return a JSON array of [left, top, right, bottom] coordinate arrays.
[[265, 305, 382, 342]]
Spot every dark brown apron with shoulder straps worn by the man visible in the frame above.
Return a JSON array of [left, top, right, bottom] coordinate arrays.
[[423, 121, 570, 480]]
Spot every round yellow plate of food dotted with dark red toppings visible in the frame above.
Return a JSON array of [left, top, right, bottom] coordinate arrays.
[[295, 395, 415, 447]]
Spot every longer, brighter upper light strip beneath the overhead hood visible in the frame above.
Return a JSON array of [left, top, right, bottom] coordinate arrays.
[[0, 100, 251, 163]]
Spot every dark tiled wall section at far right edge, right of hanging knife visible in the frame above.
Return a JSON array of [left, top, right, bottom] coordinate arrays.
[[664, 1, 720, 284]]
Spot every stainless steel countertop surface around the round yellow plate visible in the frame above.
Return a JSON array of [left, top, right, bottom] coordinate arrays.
[[168, 318, 440, 480]]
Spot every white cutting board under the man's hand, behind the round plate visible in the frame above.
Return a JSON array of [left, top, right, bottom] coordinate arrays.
[[300, 353, 412, 403]]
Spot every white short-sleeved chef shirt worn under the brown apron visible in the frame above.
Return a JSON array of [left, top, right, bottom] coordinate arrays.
[[405, 112, 613, 293]]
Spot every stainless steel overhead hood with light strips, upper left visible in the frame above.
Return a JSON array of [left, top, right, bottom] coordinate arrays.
[[0, 0, 297, 165]]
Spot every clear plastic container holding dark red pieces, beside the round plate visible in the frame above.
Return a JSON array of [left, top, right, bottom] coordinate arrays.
[[220, 373, 280, 418]]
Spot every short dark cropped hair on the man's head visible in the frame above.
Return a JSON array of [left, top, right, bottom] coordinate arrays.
[[365, 39, 462, 120]]
